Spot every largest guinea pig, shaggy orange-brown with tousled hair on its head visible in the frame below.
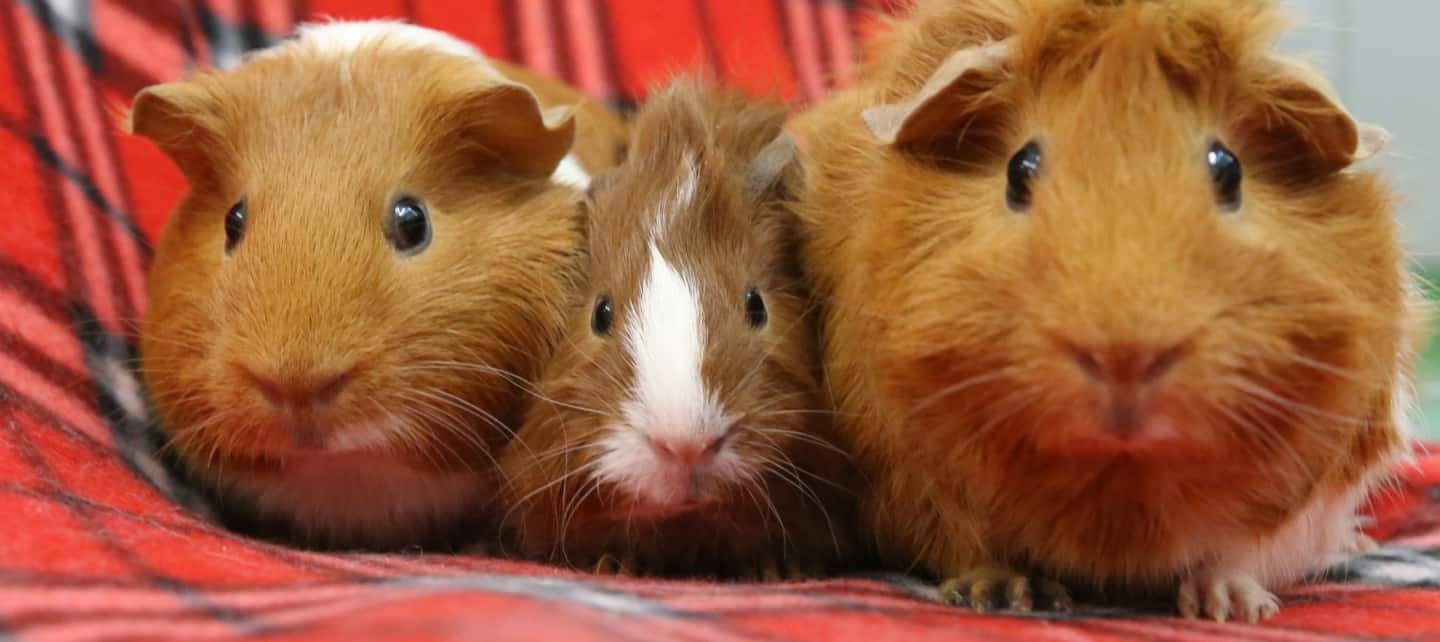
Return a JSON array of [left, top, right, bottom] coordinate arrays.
[[796, 0, 1418, 620]]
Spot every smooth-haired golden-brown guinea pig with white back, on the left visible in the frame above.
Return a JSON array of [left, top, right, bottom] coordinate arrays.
[[130, 22, 616, 548]]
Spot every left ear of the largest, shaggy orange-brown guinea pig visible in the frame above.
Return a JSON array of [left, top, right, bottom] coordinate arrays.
[[861, 40, 1014, 147]]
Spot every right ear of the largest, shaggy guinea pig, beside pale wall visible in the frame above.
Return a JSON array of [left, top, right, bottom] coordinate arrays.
[[1240, 56, 1390, 173]]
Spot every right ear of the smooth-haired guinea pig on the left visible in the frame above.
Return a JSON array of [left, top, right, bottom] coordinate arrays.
[[452, 82, 575, 178]]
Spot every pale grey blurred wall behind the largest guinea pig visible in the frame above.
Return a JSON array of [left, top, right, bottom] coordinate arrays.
[[1283, 0, 1440, 439]]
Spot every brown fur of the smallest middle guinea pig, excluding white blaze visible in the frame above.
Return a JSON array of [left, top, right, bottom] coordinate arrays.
[[501, 82, 850, 576]]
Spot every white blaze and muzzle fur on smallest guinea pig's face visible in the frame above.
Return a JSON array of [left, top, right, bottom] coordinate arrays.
[[596, 243, 746, 504]]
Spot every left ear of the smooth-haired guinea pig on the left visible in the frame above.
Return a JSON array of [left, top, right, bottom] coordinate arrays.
[[124, 81, 220, 180]]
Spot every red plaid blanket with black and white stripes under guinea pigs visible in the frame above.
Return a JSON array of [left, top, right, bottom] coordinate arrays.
[[0, 0, 1440, 641]]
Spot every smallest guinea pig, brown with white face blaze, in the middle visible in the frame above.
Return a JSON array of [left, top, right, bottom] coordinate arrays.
[[501, 79, 854, 577]]
